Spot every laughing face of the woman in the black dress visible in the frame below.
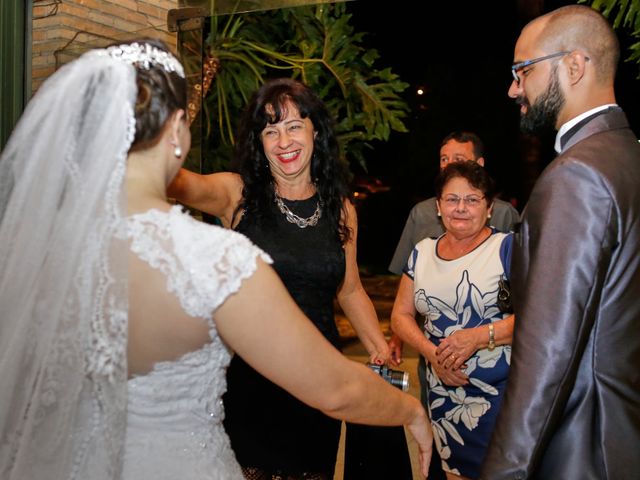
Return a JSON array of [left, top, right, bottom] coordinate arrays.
[[261, 102, 315, 181]]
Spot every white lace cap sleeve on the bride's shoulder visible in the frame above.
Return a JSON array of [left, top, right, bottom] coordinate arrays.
[[128, 206, 272, 327]]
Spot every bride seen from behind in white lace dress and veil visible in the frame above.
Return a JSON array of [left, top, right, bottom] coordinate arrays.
[[0, 41, 432, 480]]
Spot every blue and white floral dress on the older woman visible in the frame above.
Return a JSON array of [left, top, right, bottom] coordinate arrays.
[[404, 230, 513, 478]]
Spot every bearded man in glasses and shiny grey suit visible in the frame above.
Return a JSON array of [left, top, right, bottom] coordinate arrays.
[[481, 5, 640, 480]]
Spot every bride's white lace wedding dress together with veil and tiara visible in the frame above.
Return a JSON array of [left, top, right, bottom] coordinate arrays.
[[0, 44, 276, 480]]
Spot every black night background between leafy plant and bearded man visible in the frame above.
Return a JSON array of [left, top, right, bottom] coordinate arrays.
[[347, 0, 640, 273]]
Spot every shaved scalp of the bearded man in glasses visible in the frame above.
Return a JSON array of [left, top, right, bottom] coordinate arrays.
[[525, 5, 620, 84]]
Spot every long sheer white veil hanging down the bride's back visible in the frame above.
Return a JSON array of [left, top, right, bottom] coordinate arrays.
[[0, 50, 137, 480]]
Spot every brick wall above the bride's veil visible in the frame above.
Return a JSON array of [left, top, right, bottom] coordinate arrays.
[[31, 0, 179, 92]]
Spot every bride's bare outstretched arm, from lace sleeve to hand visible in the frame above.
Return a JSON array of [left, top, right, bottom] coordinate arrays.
[[214, 260, 432, 475]]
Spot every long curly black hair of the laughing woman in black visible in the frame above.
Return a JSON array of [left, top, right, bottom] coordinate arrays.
[[232, 78, 351, 243]]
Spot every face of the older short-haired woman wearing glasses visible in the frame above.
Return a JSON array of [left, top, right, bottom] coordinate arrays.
[[438, 177, 489, 238]]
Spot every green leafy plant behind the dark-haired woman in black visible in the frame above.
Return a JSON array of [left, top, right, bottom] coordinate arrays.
[[198, 3, 409, 171]]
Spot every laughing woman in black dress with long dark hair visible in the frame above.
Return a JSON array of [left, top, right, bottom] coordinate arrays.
[[170, 79, 416, 479]]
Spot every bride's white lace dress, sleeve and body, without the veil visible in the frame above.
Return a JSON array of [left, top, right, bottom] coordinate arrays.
[[124, 206, 270, 480]]
